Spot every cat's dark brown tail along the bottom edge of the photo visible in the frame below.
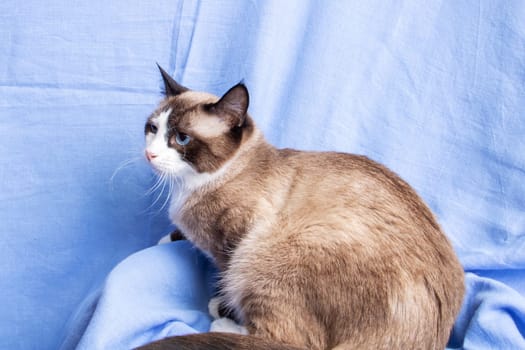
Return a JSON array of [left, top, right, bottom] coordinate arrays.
[[136, 332, 306, 350]]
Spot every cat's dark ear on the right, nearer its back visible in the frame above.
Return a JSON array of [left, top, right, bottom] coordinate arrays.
[[209, 82, 250, 128]]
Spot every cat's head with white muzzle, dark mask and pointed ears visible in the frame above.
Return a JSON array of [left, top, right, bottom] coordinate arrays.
[[145, 66, 254, 182]]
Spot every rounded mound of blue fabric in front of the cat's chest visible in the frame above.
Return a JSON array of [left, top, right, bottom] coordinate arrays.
[[70, 241, 216, 350]]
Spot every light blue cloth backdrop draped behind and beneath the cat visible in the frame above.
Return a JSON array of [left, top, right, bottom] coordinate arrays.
[[0, 0, 525, 349]]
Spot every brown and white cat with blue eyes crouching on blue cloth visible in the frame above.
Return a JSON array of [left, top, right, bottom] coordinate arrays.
[[137, 66, 464, 350]]
